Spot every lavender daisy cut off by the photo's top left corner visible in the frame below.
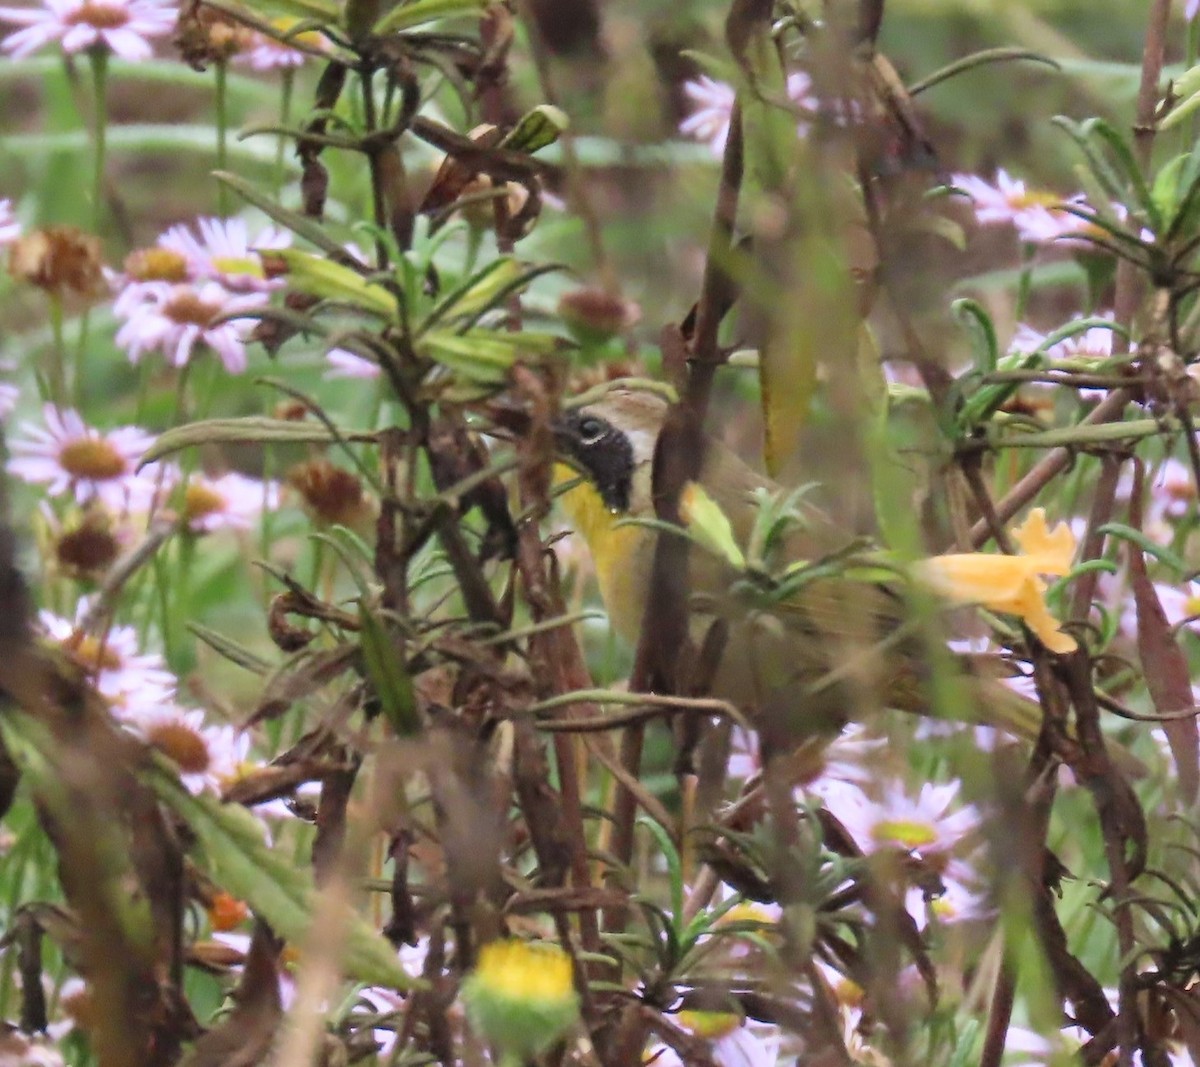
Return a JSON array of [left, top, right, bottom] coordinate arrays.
[[0, 0, 176, 62]]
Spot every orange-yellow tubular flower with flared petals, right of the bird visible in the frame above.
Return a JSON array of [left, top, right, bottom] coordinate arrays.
[[914, 508, 1076, 653]]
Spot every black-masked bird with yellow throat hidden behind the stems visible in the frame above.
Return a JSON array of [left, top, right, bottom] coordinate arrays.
[[554, 388, 1042, 743]]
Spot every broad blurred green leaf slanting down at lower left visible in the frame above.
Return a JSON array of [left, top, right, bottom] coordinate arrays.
[[143, 756, 420, 990]]
